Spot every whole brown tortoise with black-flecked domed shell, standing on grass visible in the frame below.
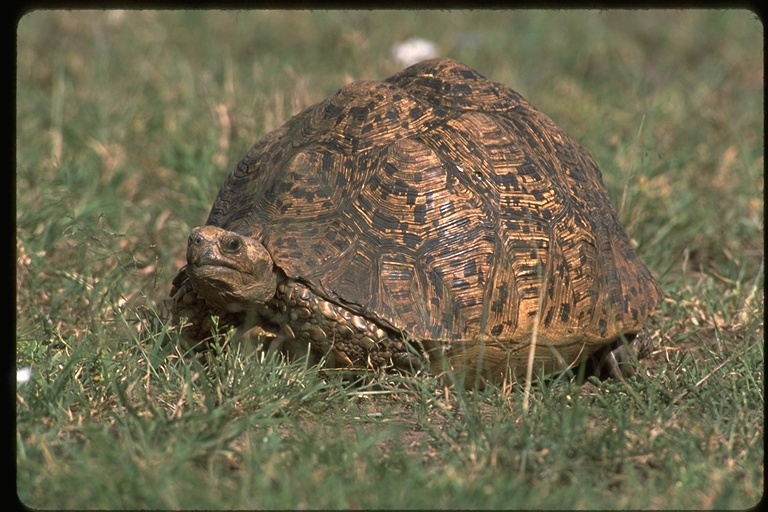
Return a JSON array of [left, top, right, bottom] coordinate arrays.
[[171, 59, 661, 380]]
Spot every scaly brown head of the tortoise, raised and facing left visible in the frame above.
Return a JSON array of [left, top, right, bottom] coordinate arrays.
[[186, 226, 277, 312]]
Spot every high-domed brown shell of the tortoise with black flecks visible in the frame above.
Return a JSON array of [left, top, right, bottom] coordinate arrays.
[[194, 59, 661, 378]]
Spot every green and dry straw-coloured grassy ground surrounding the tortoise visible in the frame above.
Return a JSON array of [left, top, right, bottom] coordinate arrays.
[[15, 11, 764, 509]]
